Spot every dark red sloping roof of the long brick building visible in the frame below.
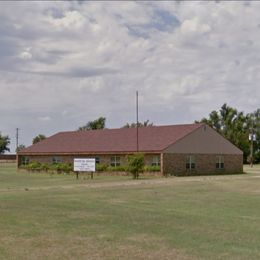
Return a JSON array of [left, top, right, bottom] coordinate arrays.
[[19, 124, 202, 154]]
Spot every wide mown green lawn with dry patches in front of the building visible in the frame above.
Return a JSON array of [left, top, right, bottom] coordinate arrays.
[[0, 165, 260, 259]]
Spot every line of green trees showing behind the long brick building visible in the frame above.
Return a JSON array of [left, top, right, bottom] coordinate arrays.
[[0, 104, 260, 163]]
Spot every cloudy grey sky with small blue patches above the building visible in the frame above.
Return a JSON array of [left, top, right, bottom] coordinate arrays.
[[0, 1, 260, 151]]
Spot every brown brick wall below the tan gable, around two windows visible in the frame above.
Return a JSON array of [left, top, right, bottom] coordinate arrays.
[[163, 153, 243, 176]]
